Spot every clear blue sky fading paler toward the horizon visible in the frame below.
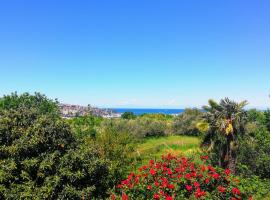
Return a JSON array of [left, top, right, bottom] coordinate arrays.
[[0, 0, 270, 108]]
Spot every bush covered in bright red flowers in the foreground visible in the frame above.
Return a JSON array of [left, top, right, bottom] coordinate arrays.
[[111, 154, 251, 200]]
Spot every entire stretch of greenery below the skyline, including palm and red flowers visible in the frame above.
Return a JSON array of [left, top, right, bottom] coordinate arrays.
[[0, 93, 270, 200]]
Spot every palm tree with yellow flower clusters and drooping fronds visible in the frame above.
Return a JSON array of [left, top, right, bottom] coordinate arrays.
[[201, 98, 247, 173]]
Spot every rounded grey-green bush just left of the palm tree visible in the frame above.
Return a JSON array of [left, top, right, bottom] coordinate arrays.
[[173, 109, 202, 135]]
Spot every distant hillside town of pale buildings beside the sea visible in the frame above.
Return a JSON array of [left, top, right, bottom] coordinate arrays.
[[59, 104, 121, 118]]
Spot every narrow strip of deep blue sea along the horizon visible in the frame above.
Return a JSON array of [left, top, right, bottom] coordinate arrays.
[[112, 108, 184, 115]]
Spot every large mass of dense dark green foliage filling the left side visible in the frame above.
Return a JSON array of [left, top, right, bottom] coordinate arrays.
[[0, 94, 112, 199]]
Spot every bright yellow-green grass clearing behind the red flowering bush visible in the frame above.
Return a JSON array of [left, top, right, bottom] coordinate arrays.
[[136, 136, 200, 164]]
